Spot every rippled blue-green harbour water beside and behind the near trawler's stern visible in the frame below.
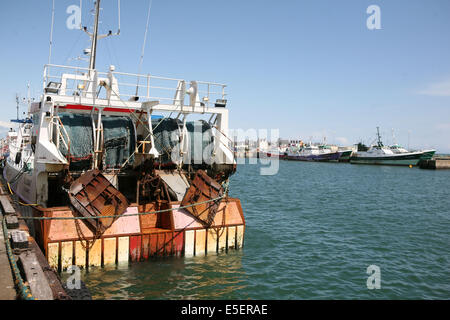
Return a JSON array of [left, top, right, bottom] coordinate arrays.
[[74, 161, 450, 299]]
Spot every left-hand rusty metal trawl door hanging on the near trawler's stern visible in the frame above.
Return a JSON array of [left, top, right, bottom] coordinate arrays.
[[69, 170, 129, 233]]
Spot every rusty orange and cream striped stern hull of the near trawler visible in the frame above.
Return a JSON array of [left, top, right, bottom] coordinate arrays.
[[33, 198, 245, 271]]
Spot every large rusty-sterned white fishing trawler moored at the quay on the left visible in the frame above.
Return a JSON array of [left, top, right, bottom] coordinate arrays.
[[3, 0, 245, 270]]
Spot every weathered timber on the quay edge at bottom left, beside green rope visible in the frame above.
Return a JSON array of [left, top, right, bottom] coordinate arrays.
[[19, 250, 53, 300]]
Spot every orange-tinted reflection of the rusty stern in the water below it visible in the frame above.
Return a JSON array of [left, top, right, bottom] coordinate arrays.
[[76, 251, 247, 299]]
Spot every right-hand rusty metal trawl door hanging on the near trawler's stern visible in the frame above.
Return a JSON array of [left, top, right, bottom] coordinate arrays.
[[181, 170, 224, 226]]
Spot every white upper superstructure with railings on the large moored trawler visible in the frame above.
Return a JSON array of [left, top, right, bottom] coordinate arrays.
[[5, 65, 235, 206]]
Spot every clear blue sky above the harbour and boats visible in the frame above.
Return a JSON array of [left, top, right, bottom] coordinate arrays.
[[0, 0, 450, 152]]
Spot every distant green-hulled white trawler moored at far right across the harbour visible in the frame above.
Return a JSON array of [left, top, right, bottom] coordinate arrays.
[[350, 127, 436, 166]]
